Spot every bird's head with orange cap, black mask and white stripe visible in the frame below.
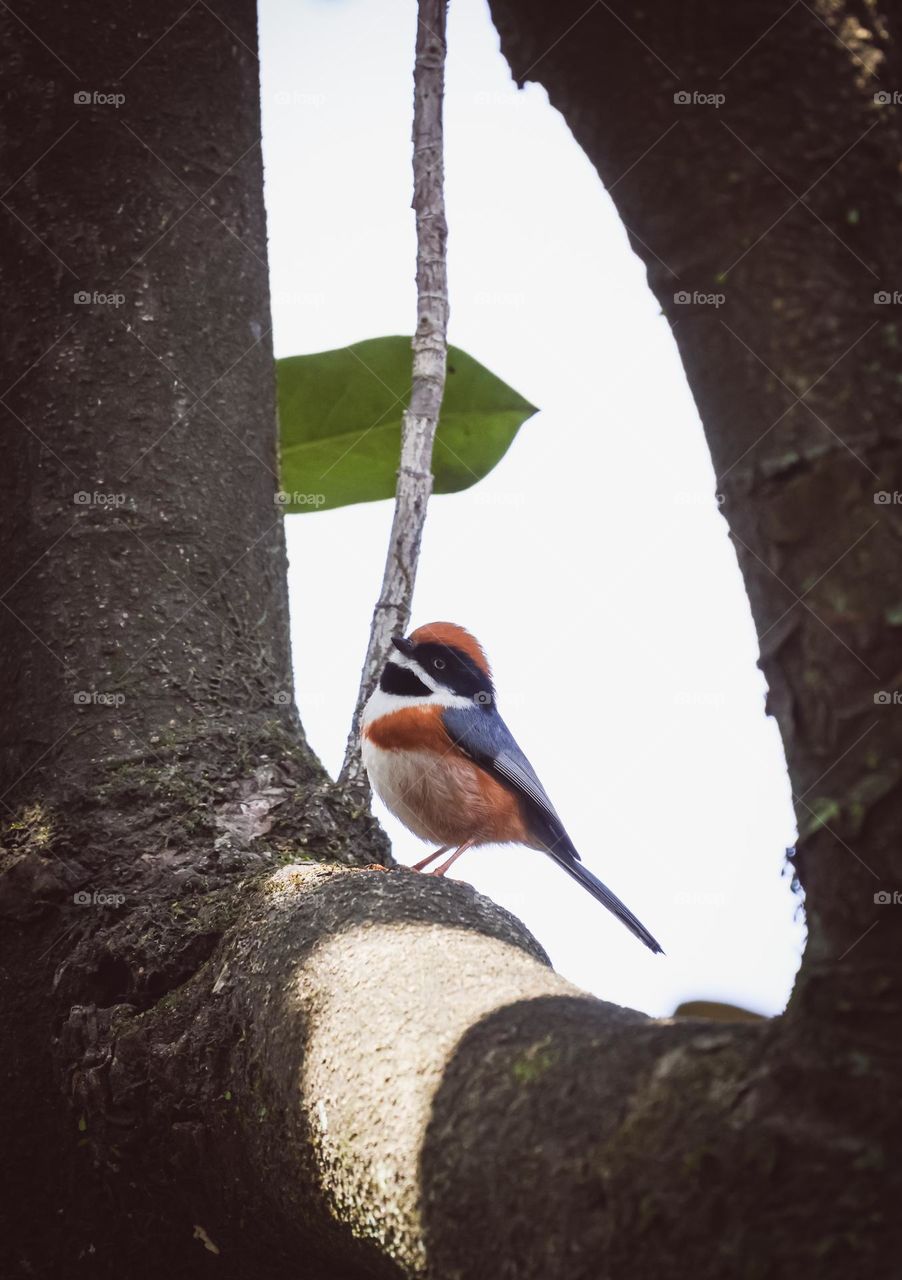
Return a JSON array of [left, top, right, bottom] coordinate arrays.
[[379, 622, 495, 707]]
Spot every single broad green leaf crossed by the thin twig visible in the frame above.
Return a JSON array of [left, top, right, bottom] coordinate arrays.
[[276, 337, 536, 512]]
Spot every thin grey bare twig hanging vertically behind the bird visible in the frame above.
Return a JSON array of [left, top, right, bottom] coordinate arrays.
[[340, 0, 448, 788]]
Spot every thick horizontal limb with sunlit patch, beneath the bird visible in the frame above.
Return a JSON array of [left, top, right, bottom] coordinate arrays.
[[63, 865, 896, 1280]]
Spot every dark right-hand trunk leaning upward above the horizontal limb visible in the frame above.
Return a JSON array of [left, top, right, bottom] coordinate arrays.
[[493, 0, 902, 983]]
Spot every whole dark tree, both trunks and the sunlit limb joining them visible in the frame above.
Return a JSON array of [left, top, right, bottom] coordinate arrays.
[[0, 0, 902, 1280]]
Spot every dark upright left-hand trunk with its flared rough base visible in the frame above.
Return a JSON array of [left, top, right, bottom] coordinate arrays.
[[0, 0, 390, 1276]]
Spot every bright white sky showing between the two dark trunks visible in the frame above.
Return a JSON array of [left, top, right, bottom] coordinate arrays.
[[254, 0, 802, 1014]]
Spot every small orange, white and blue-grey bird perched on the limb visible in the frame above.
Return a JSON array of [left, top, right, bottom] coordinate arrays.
[[361, 622, 661, 952]]
